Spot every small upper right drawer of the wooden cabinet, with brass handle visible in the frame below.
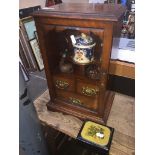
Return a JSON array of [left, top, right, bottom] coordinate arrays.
[[77, 80, 99, 97]]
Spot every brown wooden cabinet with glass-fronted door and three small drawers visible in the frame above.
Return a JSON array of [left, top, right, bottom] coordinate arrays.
[[33, 3, 125, 124]]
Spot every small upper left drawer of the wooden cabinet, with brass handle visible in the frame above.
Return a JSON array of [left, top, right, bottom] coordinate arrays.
[[54, 76, 75, 91]]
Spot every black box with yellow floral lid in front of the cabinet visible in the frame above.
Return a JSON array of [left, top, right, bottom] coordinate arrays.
[[77, 121, 114, 151]]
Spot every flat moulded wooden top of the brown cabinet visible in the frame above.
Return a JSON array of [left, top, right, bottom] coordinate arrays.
[[33, 3, 126, 22]]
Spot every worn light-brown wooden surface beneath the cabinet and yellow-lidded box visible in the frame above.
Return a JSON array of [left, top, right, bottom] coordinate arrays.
[[34, 90, 135, 155]]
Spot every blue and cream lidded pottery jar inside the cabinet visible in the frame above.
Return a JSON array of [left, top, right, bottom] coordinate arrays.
[[71, 33, 96, 65]]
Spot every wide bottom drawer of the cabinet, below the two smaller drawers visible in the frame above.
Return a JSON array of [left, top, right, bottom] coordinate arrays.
[[56, 90, 97, 110]]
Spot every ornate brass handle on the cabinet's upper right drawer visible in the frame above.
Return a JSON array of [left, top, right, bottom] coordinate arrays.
[[82, 87, 99, 96]]
